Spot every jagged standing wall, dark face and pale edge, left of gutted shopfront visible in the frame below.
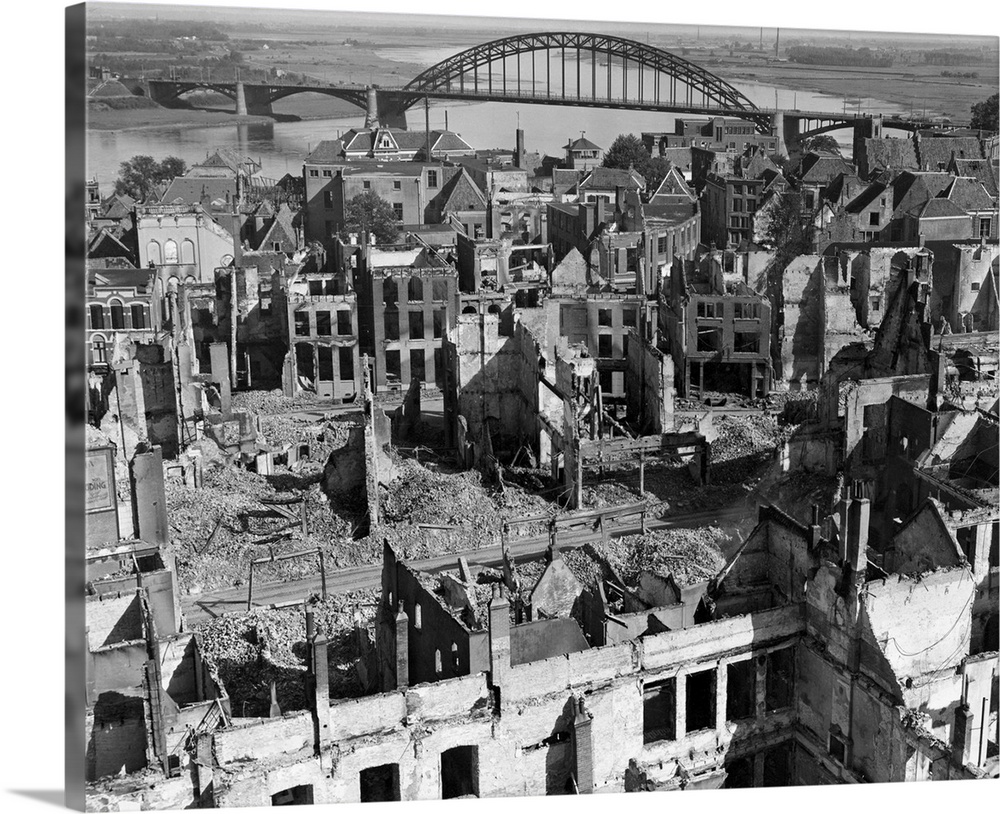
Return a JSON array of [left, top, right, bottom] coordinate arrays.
[[625, 329, 674, 435]]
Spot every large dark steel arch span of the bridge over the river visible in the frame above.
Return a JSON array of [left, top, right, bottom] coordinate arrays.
[[379, 32, 771, 132]]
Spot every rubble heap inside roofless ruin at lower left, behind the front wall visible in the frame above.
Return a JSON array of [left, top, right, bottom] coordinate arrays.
[[195, 590, 377, 717]]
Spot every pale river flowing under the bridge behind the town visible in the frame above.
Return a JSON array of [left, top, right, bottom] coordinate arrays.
[[87, 47, 906, 195]]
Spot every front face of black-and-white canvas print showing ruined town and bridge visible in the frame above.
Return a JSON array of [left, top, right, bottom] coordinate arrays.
[[80, 3, 1000, 811]]
